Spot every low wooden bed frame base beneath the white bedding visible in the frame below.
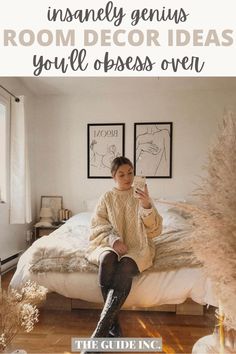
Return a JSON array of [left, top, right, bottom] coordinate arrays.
[[43, 293, 204, 315]]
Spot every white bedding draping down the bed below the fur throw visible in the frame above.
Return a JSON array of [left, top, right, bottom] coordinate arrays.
[[10, 213, 217, 307]]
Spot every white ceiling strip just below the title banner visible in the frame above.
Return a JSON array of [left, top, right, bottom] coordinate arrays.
[[19, 77, 236, 96]]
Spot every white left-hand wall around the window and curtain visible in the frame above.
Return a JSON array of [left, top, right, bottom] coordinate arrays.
[[0, 78, 35, 259]]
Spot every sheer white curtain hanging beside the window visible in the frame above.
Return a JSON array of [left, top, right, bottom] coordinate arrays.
[[10, 96, 32, 224]]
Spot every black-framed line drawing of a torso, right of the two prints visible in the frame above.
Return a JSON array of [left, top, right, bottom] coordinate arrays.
[[134, 122, 173, 178]]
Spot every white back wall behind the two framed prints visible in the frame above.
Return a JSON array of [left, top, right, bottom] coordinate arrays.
[[33, 78, 236, 213]]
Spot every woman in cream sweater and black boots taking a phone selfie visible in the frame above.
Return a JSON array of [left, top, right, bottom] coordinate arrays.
[[84, 157, 162, 352]]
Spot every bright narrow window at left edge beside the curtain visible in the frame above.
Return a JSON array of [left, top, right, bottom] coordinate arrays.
[[0, 95, 9, 202]]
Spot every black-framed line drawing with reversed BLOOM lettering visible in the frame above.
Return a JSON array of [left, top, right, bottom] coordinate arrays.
[[87, 123, 125, 178]]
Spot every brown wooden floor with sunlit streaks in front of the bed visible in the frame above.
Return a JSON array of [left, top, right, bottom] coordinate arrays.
[[3, 275, 215, 354]]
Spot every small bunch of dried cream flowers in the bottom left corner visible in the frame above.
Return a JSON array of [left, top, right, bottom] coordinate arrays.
[[0, 281, 47, 352]]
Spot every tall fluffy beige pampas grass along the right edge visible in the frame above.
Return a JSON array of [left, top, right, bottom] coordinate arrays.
[[173, 112, 236, 330]]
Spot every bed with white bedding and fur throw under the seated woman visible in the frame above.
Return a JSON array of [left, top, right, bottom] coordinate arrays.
[[10, 206, 217, 308]]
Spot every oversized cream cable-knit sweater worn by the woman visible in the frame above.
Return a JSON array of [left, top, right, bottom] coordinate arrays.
[[86, 188, 162, 272]]
